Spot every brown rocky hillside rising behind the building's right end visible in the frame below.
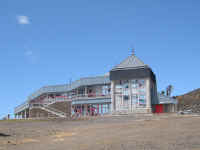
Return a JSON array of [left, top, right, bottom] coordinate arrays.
[[176, 89, 200, 113]]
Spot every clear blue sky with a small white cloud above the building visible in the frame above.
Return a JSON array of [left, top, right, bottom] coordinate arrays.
[[0, 0, 200, 117]]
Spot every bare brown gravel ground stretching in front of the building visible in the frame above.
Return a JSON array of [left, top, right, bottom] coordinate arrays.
[[0, 114, 200, 150]]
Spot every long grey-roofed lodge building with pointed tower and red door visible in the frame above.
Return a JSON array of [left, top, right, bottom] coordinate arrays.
[[14, 51, 177, 118]]
